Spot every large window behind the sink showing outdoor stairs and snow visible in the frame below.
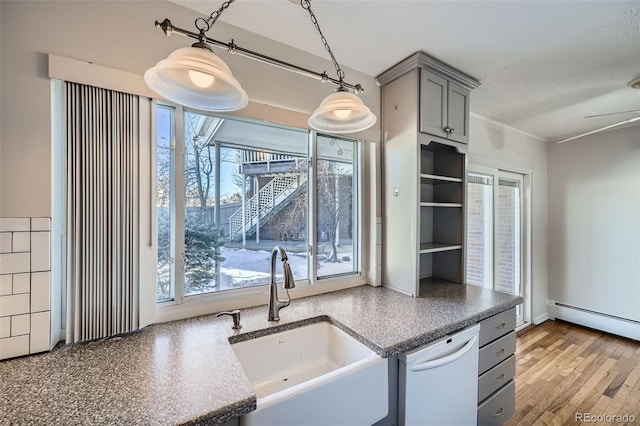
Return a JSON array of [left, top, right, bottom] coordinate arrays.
[[156, 104, 360, 303]]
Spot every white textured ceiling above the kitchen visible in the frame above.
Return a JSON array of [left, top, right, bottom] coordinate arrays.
[[175, 0, 640, 141]]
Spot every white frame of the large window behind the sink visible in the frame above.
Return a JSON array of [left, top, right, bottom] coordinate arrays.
[[151, 100, 368, 322]]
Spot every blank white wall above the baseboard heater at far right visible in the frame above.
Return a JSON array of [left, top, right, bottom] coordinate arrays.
[[549, 126, 640, 321]]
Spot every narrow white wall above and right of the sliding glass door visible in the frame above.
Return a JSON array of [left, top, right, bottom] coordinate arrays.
[[468, 115, 548, 323]]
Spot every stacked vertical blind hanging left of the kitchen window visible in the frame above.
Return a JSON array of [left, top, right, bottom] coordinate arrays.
[[65, 82, 139, 343]]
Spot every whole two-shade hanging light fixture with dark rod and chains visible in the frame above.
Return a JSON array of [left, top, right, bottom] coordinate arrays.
[[144, 0, 377, 134]]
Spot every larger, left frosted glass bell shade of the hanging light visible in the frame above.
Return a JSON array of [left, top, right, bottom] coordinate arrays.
[[144, 46, 249, 111]]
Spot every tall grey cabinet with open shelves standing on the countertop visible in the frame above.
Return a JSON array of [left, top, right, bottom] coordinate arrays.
[[376, 52, 479, 297]]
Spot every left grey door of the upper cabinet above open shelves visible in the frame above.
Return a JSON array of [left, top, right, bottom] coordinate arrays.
[[420, 69, 448, 138]]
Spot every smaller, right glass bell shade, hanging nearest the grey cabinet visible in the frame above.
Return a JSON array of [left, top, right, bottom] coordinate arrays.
[[308, 89, 377, 134]]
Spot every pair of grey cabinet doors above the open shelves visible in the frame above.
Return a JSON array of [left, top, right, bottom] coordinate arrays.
[[420, 69, 469, 143]]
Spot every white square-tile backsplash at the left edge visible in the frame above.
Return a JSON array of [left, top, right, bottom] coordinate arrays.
[[0, 217, 51, 359]]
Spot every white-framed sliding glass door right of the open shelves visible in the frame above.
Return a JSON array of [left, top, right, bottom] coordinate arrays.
[[466, 165, 524, 322]]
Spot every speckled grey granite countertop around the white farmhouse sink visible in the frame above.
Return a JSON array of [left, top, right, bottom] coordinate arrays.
[[0, 284, 522, 425]]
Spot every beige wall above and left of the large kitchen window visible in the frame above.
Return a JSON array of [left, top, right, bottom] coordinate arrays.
[[0, 0, 380, 217]]
